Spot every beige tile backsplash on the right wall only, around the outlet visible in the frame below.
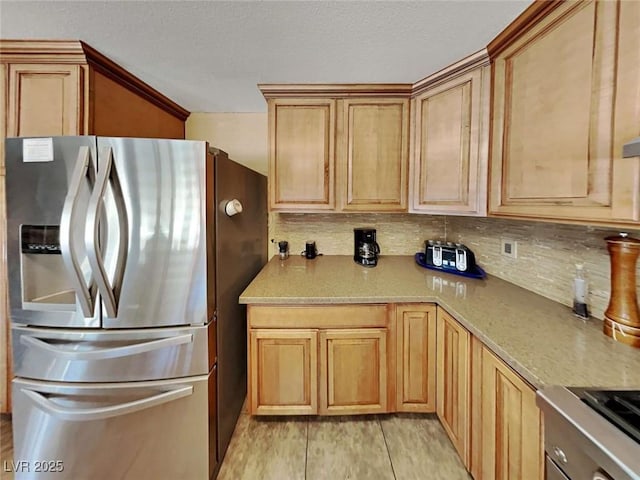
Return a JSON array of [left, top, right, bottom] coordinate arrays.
[[447, 217, 640, 319]]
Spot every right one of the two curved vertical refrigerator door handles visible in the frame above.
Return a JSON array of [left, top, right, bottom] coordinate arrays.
[[85, 147, 129, 317]]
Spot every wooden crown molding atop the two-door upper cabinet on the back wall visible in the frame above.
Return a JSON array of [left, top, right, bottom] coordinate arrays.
[[258, 83, 412, 99]]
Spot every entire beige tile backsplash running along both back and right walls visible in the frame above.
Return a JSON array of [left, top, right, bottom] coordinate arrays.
[[269, 213, 640, 319]]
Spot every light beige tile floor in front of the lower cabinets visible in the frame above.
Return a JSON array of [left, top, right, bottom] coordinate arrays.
[[0, 412, 471, 480]]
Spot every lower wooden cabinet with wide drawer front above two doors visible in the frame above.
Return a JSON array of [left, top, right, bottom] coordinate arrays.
[[248, 305, 395, 415]]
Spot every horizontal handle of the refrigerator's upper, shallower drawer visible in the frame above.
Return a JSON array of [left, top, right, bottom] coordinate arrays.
[[20, 334, 193, 360]]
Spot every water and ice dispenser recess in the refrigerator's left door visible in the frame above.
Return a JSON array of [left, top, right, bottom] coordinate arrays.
[[20, 225, 76, 311]]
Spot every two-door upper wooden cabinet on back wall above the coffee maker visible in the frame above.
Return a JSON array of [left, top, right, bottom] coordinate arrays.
[[259, 84, 411, 212]]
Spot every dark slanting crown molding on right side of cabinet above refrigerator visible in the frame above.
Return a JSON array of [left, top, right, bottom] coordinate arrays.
[[80, 41, 191, 122]]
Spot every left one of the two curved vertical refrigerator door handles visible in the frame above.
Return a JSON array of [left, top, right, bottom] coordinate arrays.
[[60, 146, 94, 318]]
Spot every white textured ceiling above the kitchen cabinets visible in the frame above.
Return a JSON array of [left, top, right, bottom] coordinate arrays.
[[0, 0, 530, 112]]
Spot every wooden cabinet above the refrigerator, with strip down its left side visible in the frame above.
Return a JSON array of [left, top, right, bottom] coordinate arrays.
[[0, 40, 189, 412]]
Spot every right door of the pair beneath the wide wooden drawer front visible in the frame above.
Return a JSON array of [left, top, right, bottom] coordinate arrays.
[[320, 328, 388, 415]]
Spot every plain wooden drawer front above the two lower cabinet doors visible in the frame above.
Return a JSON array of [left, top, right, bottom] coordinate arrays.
[[247, 305, 388, 328]]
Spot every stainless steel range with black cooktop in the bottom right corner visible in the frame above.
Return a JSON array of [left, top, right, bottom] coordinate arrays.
[[537, 387, 640, 480]]
